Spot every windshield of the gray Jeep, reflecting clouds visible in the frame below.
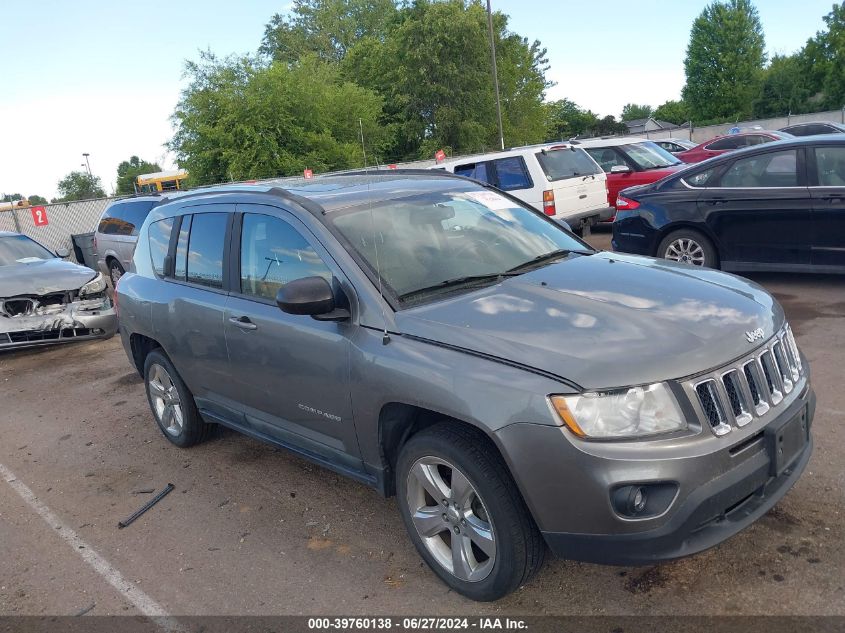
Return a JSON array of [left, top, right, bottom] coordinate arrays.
[[327, 188, 592, 302]]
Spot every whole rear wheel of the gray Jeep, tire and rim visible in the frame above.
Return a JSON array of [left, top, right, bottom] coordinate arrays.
[[144, 349, 212, 448]]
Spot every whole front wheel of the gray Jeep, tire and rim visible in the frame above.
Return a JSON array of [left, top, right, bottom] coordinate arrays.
[[396, 422, 545, 601]]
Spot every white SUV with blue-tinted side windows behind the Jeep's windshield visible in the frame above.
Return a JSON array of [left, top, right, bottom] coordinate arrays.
[[431, 143, 614, 232]]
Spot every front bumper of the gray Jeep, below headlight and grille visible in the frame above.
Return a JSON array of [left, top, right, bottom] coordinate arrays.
[[499, 384, 815, 565]]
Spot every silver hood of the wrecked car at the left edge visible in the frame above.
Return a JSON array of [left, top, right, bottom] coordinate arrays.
[[0, 258, 97, 297]]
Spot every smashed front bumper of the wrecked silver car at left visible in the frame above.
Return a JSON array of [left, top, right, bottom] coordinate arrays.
[[0, 298, 117, 350]]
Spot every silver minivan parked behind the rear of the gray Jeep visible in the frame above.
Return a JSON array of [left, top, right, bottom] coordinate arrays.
[[94, 196, 162, 287]]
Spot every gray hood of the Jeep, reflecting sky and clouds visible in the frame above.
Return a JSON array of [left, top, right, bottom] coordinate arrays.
[[396, 253, 784, 390]]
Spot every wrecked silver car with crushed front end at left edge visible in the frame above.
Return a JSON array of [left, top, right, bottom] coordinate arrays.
[[0, 231, 117, 350]]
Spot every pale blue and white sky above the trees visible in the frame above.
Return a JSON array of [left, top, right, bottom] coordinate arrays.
[[0, 0, 832, 198]]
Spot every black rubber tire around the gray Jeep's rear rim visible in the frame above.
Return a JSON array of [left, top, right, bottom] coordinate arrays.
[[144, 348, 214, 448]]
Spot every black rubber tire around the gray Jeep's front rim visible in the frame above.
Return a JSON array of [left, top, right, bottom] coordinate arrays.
[[396, 420, 546, 602]]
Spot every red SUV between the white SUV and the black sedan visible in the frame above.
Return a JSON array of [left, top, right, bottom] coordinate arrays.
[[578, 138, 685, 222]]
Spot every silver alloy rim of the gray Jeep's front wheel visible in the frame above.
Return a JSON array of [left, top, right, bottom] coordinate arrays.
[[406, 457, 496, 582]]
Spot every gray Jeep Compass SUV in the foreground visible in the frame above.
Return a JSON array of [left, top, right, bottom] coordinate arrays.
[[117, 172, 815, 600]]
